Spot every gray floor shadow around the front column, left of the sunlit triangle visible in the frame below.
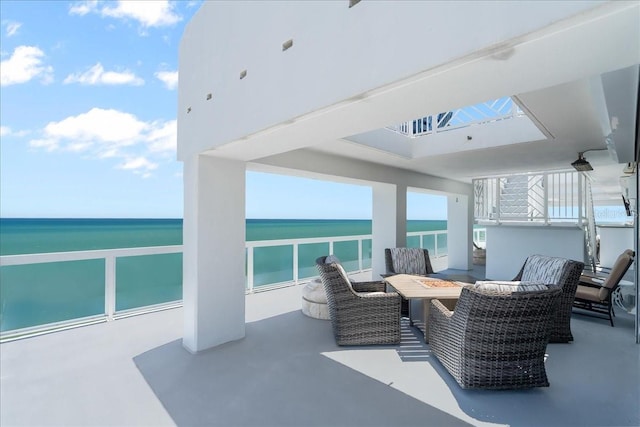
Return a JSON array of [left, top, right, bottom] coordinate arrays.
[[134, 312, 468, 426]]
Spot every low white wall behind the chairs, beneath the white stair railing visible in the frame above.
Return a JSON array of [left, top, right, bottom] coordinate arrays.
[[486, 225, 584, 280]]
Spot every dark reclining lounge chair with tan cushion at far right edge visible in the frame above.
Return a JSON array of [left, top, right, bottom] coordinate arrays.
[[573, 249, 636, 326]]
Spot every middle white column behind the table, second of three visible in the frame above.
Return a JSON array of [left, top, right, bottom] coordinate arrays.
[[371, 184, 407, 279]]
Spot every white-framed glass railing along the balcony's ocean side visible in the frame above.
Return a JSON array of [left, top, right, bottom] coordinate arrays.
[[0, 229, 484, 340]]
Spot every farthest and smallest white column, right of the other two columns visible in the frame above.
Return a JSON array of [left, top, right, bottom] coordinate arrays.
[[447, 195, 473, 270]]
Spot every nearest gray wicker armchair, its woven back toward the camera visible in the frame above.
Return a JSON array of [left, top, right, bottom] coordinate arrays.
[[429, 285, 562, 389]]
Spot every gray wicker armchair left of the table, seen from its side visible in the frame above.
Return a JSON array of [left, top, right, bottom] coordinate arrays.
[[316, 257, 401, 345]]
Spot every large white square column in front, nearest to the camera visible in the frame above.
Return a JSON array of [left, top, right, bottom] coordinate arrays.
[[182, 155, 246, 353]]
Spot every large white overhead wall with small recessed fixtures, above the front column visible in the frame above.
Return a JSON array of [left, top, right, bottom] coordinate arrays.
[[178, 0, 624, 160]]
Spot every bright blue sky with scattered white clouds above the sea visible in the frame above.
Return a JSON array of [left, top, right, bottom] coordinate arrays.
[[0, 0, 446, 219]]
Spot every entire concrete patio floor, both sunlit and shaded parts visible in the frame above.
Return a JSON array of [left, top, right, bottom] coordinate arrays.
[[0, 272, 640, 427]]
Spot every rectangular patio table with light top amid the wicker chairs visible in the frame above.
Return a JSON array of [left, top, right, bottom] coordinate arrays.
[[384, 274, 469, 343]]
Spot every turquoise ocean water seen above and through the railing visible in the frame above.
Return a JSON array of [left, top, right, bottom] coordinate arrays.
[[0, 218, 447, 332]]
